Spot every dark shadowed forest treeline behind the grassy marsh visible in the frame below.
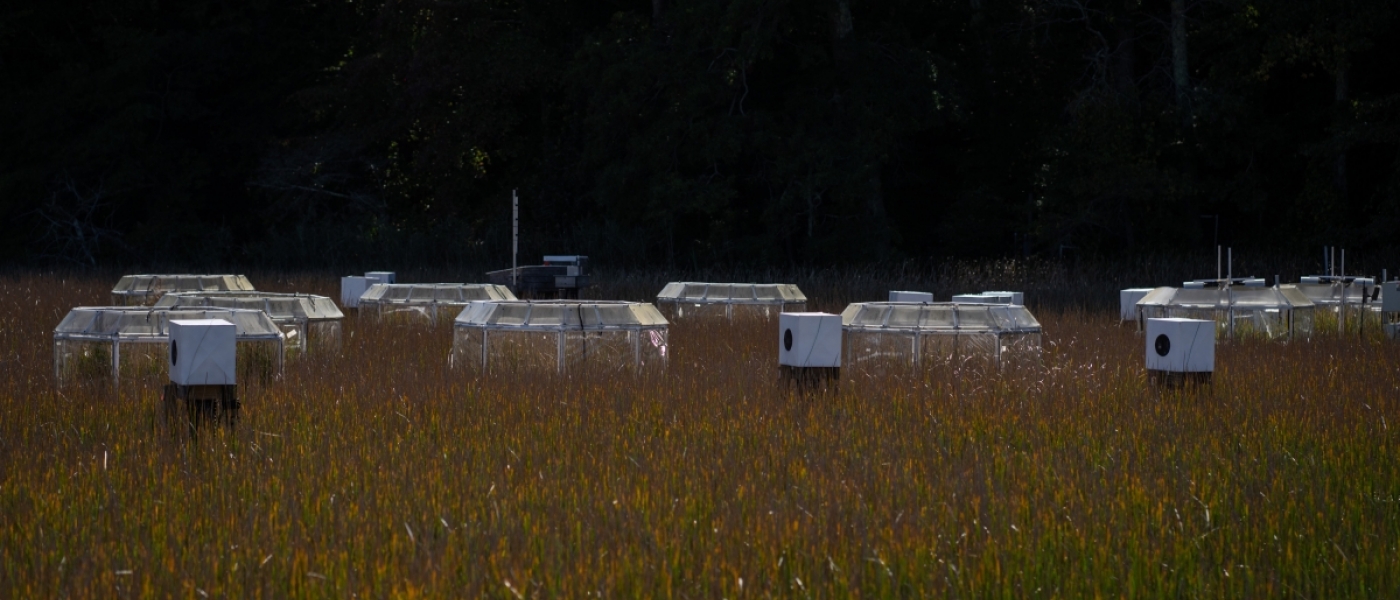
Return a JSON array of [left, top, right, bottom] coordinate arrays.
[[0, 0, 1400, 267]]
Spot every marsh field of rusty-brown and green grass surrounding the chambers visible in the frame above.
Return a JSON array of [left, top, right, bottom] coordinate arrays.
[[0, 267, 1400, 599]]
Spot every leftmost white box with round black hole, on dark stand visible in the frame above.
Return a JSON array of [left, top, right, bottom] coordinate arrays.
[[167, 319, 238, 386]]
